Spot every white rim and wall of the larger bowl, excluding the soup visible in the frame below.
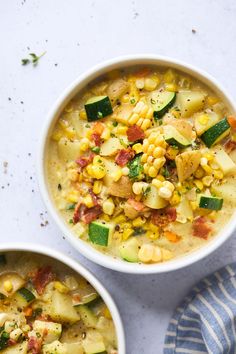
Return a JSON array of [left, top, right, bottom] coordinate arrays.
[[38, 54, 236, 274]]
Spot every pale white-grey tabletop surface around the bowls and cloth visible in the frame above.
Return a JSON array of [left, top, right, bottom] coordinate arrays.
[[0, 0, 236, 354]]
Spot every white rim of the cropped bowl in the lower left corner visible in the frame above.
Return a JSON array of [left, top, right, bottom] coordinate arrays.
[[0, 242, 125, 354]]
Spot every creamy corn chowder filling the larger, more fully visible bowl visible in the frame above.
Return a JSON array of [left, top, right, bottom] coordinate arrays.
[[46, 67, 236, 263]]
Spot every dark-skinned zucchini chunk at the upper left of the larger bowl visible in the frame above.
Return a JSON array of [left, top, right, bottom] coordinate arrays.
[[84, 96, 113, 122]]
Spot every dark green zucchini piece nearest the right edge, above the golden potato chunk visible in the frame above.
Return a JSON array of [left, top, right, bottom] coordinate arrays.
[[201, 118, 230, 147]]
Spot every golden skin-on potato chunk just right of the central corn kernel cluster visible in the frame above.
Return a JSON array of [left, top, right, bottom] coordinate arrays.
[[175, 150, 201, 182]]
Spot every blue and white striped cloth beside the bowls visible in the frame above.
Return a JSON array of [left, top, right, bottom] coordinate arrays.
[[164, 263, 236, 354]]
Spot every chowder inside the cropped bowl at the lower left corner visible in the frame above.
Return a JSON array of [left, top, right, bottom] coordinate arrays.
[[0, 252, 118, 354]]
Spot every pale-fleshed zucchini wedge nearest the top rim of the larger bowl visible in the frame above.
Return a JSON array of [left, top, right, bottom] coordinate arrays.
[[150, 91, 176, 120]]
